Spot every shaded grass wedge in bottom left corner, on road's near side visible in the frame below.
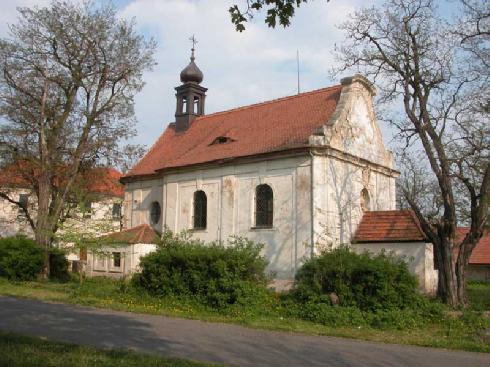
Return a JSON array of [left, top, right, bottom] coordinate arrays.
[[0, 332, 216, 367]]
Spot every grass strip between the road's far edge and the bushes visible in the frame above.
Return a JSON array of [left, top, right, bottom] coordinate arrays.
[[0, 278, 490, 353]]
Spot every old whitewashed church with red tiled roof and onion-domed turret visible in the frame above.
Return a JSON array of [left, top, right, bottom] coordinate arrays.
[[121, 49, 414, 279]]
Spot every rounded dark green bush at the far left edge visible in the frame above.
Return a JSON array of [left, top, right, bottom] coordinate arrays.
[[0, 236, 44, 280]]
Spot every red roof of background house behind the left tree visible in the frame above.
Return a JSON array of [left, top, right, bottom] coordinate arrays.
[[0, 161, 124, 198]]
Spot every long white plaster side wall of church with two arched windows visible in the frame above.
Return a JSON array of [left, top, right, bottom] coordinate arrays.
[[126, 156, 311, 278]]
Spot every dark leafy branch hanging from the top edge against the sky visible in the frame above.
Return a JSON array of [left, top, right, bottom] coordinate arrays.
[[228, 0, 330, 32]]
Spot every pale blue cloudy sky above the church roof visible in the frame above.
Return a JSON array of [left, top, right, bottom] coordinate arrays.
[[0, 0, 402, 147]]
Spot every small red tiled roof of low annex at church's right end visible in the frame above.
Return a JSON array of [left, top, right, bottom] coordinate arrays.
[[353, 210, 427, 242]]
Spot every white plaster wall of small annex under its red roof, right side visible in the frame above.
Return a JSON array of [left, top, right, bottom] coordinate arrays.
[[351, 242, 438, 295]]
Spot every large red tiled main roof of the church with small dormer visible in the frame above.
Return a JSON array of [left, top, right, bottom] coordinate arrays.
[[123, 85, 342, 178]]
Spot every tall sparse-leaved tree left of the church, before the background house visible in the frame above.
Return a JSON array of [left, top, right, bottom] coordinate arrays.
[[0, 1, 155, 276]]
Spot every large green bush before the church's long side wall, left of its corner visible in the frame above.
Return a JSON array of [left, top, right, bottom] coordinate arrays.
[[132, 232, 267, 308]]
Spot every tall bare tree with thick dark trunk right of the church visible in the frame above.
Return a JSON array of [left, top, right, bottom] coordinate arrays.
[[232, 0, 490, 306]]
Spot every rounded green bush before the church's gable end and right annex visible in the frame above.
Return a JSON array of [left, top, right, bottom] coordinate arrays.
[[293, 247, 420, 311]]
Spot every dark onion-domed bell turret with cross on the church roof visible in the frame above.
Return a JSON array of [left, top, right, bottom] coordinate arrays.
[[175, 36, 207, 132]]
